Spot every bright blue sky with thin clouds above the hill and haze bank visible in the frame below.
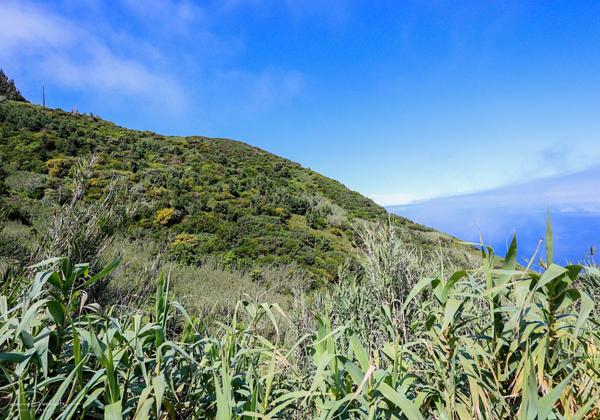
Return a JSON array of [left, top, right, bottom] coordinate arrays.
[[0, 0, 600, 204]]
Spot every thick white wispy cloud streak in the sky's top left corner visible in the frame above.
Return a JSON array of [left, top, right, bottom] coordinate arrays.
[[0, 2, 186, 111]]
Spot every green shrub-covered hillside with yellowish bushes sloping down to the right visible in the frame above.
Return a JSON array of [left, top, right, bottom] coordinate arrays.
[[0, 100, 478, 279]]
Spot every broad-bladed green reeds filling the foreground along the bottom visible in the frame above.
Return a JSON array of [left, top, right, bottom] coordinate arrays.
[[0, 230, 600, 419]]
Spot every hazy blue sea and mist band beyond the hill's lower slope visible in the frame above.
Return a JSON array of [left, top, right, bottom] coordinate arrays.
[[387, 166, 600, 263]]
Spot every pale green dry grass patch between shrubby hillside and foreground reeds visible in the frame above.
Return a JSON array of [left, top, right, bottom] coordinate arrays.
[[100, 237, 310, 320]]
